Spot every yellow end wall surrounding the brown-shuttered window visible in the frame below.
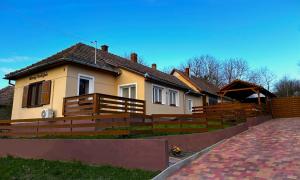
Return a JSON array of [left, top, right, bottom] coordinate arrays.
[[12, 66, 67, 119]]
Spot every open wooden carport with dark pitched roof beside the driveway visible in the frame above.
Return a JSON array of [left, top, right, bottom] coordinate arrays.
[[219, 80, 276, 105]]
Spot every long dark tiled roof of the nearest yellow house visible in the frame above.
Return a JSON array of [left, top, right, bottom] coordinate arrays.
[[5, 43, 195, 90]]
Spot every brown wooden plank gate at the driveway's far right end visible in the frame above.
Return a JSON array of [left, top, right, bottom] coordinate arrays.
[[272, 97, 300, 118]]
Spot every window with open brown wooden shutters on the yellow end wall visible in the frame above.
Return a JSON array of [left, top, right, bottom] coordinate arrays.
[[22, 80, 51, 108]]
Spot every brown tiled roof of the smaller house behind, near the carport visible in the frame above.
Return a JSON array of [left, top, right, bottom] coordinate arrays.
[[173, 69, 220, 96]]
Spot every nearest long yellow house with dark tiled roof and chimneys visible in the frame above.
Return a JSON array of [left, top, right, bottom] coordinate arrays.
[[5, 43, 202, 119]]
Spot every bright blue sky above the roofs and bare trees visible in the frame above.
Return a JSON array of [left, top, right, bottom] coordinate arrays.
[[0, 0, 300, 88]]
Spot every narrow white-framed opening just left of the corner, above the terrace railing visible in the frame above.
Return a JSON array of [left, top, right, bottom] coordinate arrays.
[[78, 75, 94, 96]]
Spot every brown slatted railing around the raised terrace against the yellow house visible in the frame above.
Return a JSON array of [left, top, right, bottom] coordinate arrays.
[[63, 93, 146, 116]]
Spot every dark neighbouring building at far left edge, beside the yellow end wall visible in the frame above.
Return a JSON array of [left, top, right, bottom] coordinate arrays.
[[0, 86, 14, 119]]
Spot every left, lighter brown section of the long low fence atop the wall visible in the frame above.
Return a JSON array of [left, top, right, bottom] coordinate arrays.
[[0, 113, 130, 137]]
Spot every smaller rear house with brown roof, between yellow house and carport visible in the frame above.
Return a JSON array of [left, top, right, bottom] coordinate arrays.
[[171, 68, 221, 106]]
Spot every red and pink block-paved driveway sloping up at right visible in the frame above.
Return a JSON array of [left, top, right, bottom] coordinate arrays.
[[168, 118, 300, 180]]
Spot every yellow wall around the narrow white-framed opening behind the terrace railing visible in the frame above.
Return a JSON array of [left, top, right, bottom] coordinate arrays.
[[66, 65, 117, 97]]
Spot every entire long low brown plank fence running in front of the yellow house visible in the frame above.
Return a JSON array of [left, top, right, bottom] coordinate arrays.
[[0, 113, 240, 137]]
